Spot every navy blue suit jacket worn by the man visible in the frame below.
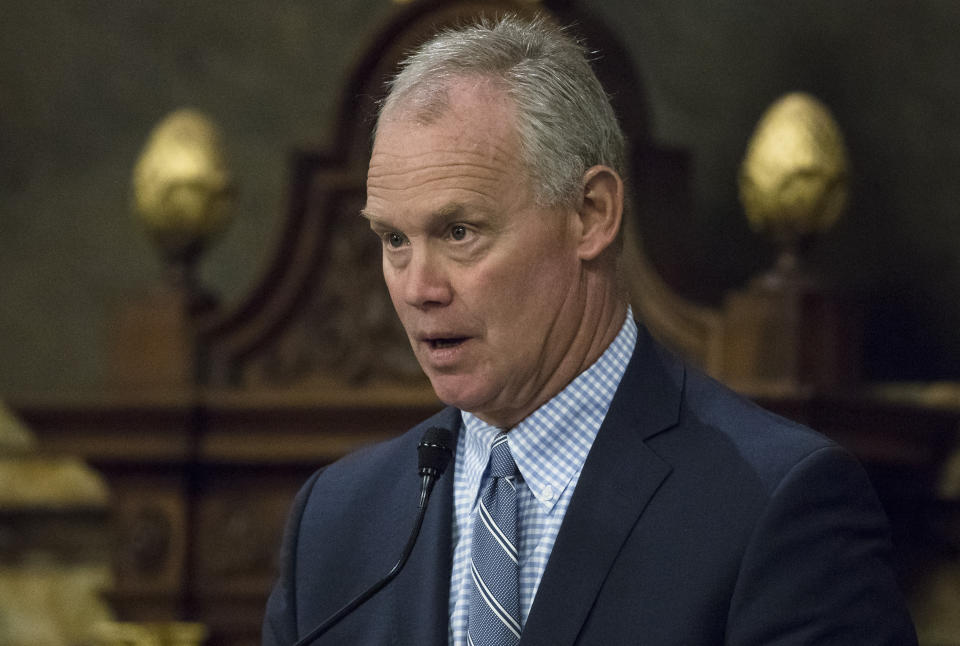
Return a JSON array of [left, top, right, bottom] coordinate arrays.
[[264, 328, 916, 646]]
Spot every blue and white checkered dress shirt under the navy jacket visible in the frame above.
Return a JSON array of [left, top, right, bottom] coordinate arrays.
[[450, 310, 637, 646]]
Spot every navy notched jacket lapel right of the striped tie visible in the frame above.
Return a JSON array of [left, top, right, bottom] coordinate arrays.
[[521, 327, 683, 646]]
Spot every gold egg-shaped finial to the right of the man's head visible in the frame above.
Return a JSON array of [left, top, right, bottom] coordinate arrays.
[[739, 92, 849, 284]]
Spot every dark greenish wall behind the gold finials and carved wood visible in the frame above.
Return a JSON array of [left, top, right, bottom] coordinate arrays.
[[0, 0, 960, 393]]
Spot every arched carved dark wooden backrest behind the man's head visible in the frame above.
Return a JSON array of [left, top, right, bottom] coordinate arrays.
[[200, 0, 713, 389]]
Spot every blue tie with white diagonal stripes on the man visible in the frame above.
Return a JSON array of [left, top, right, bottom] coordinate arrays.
[[467, 433, 520, 646]]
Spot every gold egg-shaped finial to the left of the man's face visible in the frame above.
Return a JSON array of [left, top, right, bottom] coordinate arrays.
[[133, 109, 232, 262]]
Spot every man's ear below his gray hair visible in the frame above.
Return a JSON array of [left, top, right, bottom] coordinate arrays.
[[578, 166, 623, 260]]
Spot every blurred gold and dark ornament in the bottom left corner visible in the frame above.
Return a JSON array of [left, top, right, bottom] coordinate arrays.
[[0, 402, 113, 646]]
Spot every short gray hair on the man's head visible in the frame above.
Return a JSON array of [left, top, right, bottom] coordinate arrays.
[[380, 15, 624, 206]]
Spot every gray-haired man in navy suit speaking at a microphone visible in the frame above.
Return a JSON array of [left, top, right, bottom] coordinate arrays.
[[264, 18, 916, 646]]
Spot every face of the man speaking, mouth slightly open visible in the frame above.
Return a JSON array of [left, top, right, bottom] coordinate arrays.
[[364, 82, 585, 427]]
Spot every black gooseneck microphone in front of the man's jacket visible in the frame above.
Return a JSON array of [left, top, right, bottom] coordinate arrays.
[[293, 426, 453, 646]]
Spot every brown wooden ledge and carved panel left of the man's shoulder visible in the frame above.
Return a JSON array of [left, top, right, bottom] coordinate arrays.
[[12, 384, 440, 646]]
